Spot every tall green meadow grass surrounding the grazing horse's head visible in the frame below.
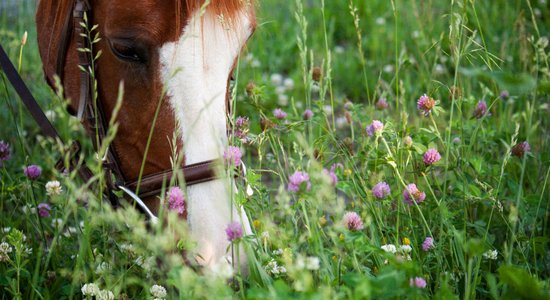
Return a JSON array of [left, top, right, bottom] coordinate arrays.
[[0, 0, 550, 299]]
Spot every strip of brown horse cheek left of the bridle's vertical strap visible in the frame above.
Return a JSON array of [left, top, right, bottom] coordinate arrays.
[[36, 0, 80, 114]]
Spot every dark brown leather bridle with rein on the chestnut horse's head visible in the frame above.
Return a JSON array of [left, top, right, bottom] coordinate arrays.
[[0, 0, 234, 221]]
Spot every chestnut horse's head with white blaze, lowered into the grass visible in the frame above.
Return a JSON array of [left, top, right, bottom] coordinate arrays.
[[36, 0, 256, 267]]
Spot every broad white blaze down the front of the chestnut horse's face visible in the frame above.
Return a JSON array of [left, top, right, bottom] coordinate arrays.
[[159, 11, 251, 266]]
